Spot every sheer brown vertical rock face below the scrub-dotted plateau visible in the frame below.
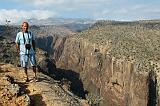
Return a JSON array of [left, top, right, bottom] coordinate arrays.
[[57, 38, 149, 106]]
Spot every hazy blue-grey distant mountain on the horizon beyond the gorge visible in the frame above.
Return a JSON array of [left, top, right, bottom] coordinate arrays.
[[28, 18, 96, 32]]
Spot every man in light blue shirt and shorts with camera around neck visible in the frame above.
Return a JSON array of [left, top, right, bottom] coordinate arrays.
[[15, 22, 37, 82]]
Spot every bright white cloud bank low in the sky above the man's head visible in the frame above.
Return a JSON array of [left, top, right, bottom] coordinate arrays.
[[0, 9, 57, 24]]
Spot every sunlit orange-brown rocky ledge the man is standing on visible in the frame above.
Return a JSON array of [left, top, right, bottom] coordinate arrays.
[[0, 64, 88, 106]]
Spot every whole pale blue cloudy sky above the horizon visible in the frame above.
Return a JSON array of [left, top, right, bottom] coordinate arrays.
[[0, 0, 160, 24]]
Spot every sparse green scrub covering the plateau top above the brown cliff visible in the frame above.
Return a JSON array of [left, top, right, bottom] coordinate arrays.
[[75, 21, 160, 71]]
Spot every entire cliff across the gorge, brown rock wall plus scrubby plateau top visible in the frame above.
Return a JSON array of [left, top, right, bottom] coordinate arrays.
[[56, 21, 160, 106]]
